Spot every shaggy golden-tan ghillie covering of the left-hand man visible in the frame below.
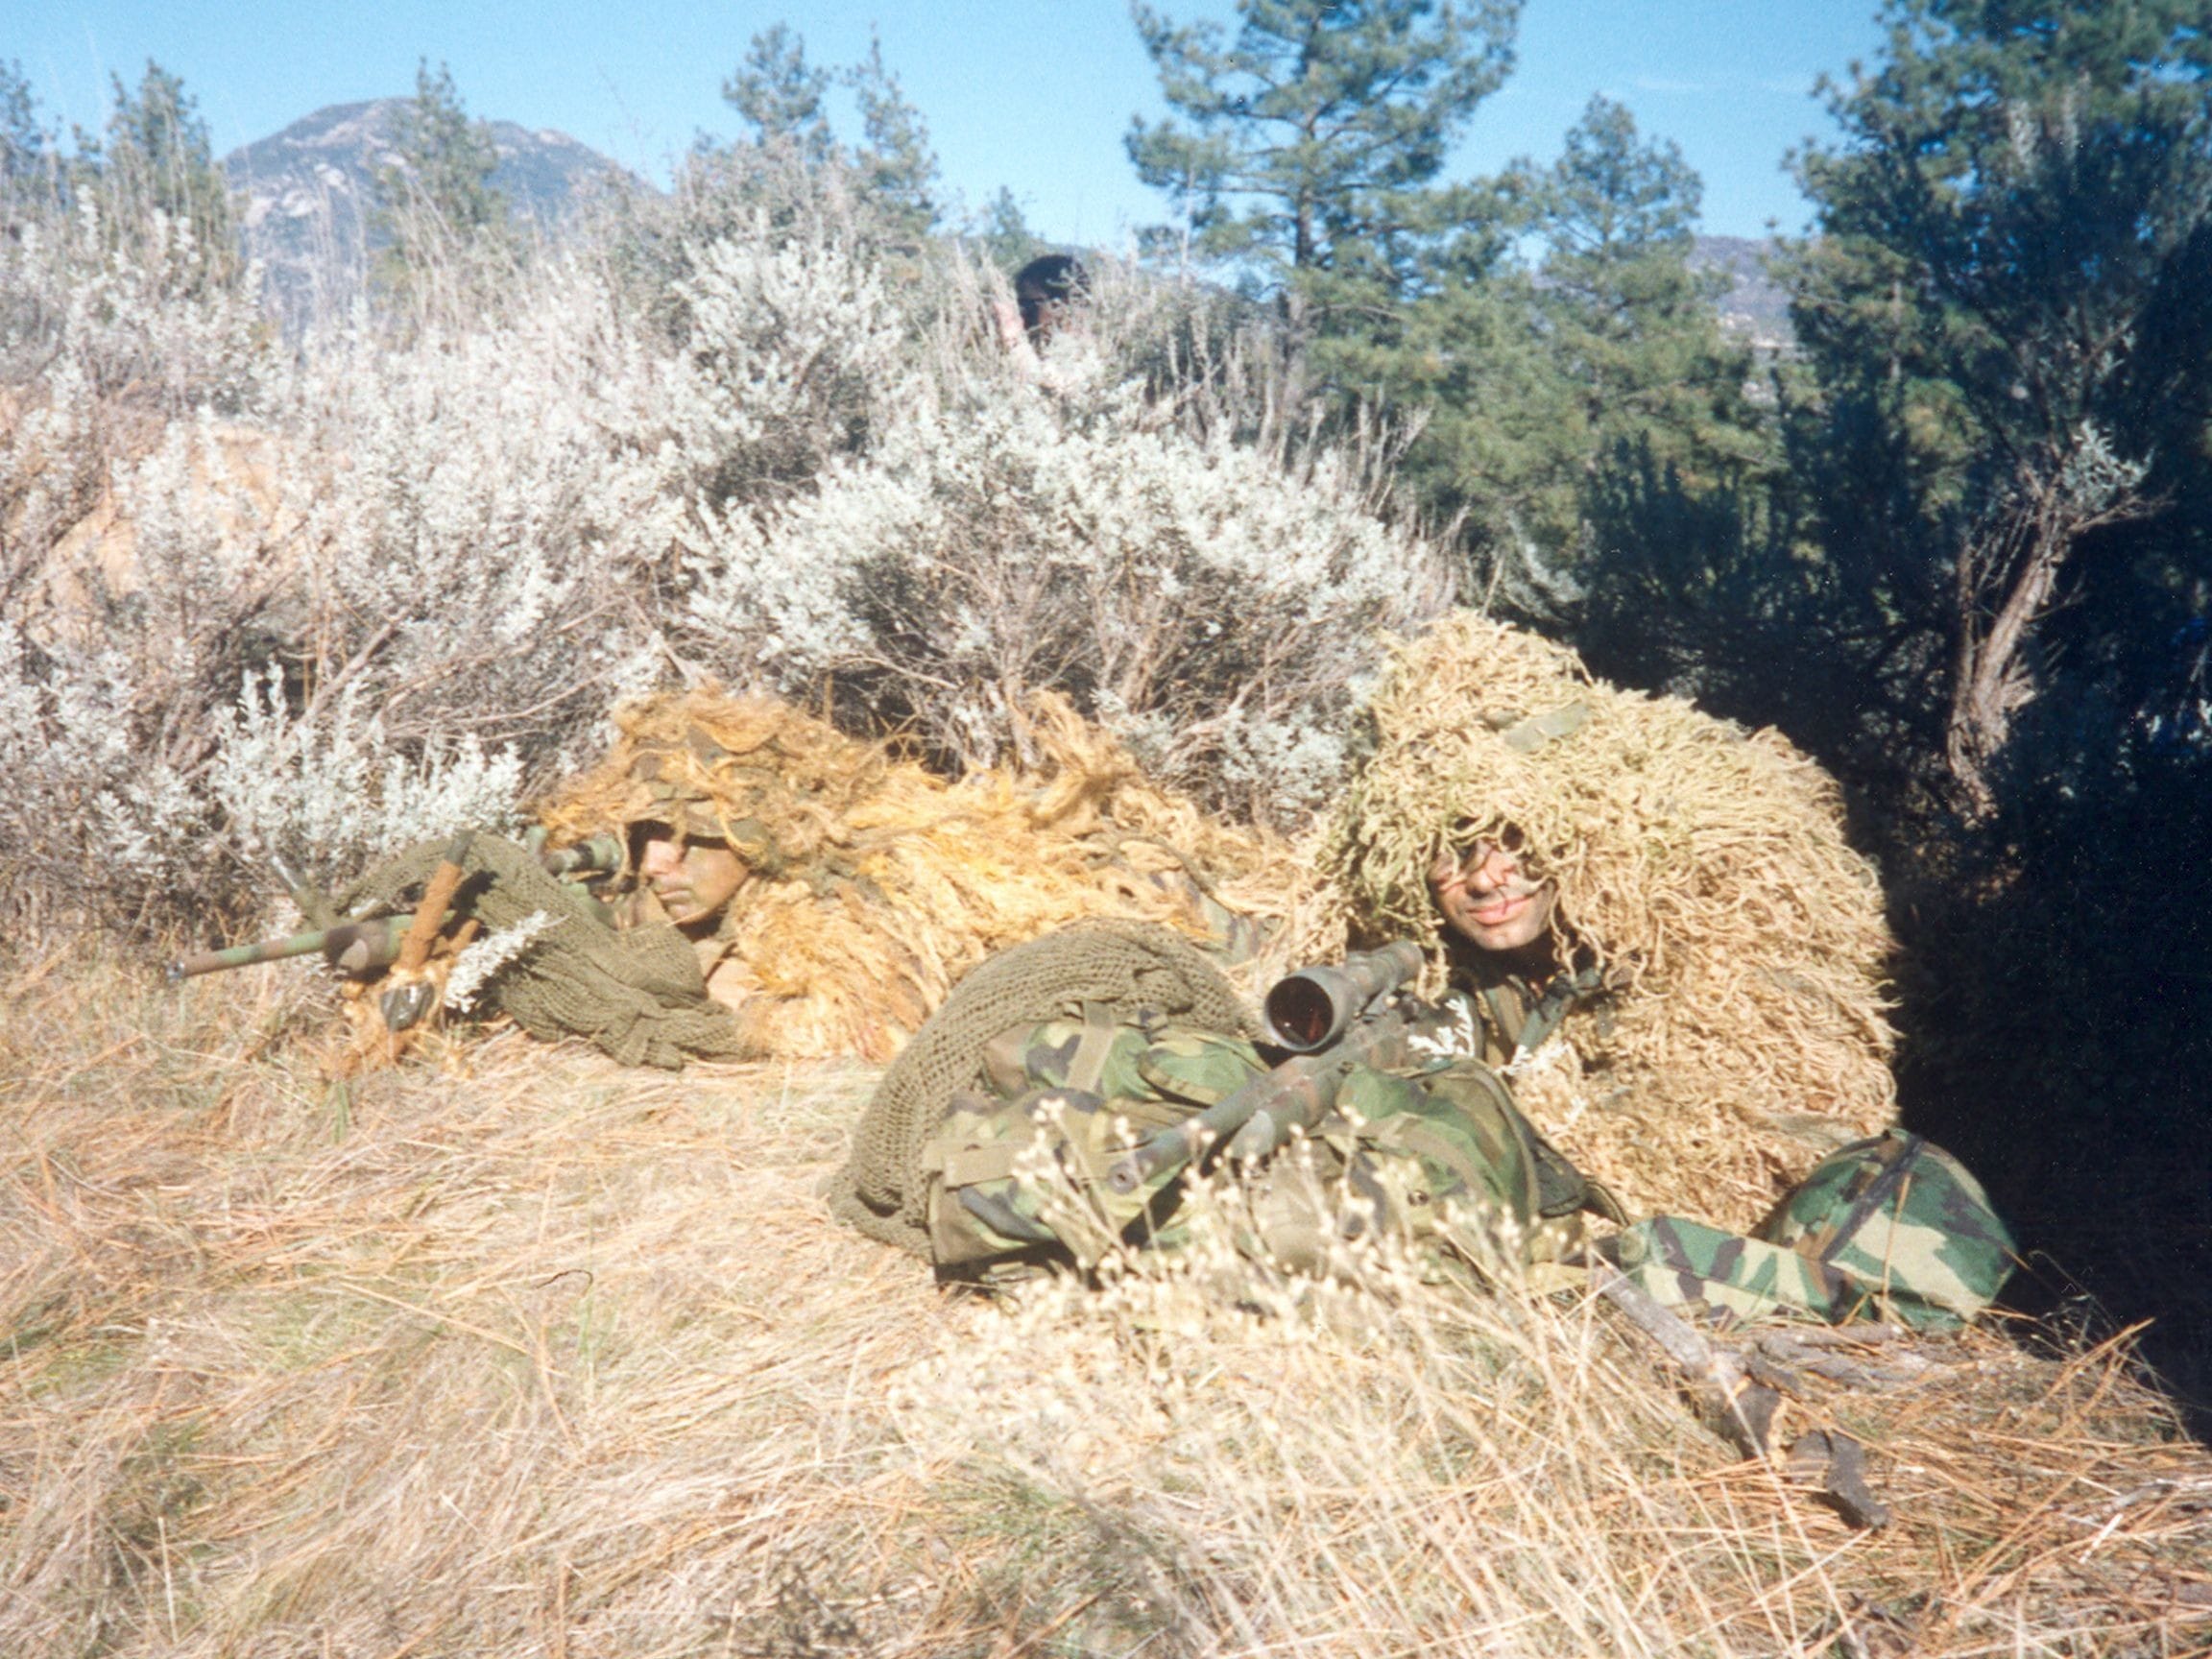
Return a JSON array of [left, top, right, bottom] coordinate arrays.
[[526, 692, 1310, 1060]]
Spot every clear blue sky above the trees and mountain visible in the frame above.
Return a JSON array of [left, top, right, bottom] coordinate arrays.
[[0, 0, 1880, 246]]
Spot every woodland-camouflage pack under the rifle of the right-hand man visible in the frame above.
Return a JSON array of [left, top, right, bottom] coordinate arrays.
[[925, 1009, 1581, 1281]]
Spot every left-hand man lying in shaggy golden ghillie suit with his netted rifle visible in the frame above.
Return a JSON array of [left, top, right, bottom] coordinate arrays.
[[302, 690, 1296, 1067]]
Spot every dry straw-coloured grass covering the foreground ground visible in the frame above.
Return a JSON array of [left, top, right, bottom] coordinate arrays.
[[0, 962, 2212, 1659]]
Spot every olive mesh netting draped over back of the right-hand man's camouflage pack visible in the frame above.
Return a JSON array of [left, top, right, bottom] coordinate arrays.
[[828, 920, 1259, 1257]]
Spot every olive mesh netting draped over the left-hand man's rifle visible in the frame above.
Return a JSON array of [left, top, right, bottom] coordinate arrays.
[[336, 836, 743, 1067]]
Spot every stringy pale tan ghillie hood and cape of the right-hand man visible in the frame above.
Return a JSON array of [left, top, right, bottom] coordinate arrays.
[[1320, 613, 1896, 1228]]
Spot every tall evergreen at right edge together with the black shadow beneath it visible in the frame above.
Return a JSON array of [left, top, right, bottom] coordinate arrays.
[[1791, 0, 2212, 1394]]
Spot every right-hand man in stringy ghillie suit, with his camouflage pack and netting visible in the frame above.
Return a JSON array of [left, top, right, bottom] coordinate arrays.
[[830, 615, 2010, 1330]]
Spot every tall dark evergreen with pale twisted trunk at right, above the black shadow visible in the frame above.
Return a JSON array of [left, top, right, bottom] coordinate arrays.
[[1794, 0, 2212, 812]]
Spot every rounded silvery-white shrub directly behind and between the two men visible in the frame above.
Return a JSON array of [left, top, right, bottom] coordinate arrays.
[[688, 376, 1449, 812]]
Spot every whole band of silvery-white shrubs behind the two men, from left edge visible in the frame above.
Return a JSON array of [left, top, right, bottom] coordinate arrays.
[[0, 180, 1445, 931]]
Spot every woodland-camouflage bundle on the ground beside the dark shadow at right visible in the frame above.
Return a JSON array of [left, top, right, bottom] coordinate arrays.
[[1615, 1128, 2015, 1330]]
